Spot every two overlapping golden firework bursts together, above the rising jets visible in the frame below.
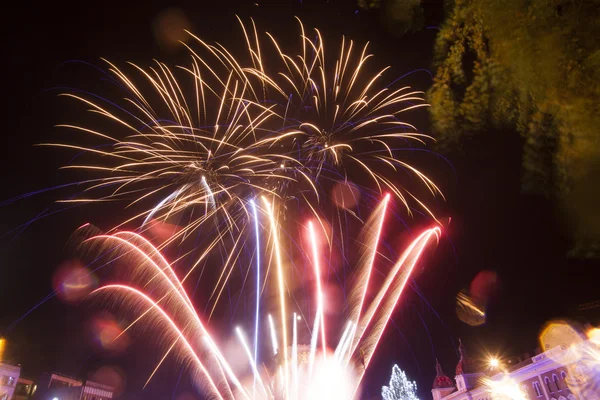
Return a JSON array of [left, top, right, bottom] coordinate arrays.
[[52, 21, 439, 241]]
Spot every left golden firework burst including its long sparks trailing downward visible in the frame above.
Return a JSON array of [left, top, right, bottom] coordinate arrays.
[[48, 59, 304, 318]]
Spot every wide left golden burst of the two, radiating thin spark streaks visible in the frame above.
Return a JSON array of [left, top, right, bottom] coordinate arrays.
[[50, 55, 297, 253]]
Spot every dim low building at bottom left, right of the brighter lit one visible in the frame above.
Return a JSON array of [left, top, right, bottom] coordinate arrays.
[[33, 373, 114, 400]]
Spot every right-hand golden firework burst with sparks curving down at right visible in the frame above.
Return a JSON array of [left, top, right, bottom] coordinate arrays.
[[227, 19, 443, 218]]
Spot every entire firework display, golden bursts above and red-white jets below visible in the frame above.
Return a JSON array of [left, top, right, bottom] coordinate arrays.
[[41, 21, 446, 399]]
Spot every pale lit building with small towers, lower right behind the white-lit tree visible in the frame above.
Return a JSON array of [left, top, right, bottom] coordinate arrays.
[[431, 342, 600, 400]]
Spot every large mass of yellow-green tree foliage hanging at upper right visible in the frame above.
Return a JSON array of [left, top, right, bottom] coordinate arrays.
[[429, 0, 600, 256]]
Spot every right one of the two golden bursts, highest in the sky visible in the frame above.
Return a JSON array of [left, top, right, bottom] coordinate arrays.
[[196, 19, 441, 218]]
